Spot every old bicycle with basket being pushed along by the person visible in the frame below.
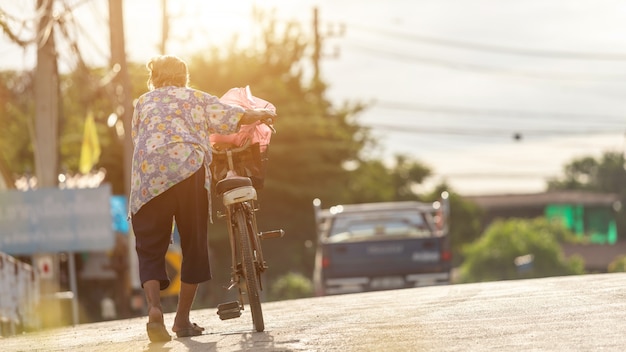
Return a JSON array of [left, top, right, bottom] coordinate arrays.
[[212, 119, 285, 332]]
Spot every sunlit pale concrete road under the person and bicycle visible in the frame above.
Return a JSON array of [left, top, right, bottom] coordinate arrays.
[[0, 274, 626, 352]]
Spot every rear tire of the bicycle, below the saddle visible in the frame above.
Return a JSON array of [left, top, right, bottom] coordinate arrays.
[[235, 208, 265, 332]]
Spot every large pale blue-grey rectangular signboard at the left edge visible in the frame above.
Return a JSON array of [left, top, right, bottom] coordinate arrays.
[[0, 185, 115, 255]]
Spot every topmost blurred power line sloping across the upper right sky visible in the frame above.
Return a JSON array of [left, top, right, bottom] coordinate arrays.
[[349, 23, 626, 61]]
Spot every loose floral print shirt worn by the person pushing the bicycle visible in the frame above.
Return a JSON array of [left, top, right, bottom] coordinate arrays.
[[129, 86, 244, 216]]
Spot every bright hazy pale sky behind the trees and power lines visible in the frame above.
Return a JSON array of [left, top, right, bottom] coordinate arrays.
[[0, 0, 626, 195]]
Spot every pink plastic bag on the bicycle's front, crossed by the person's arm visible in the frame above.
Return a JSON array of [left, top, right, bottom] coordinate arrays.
[[209, 86, 276, 152]]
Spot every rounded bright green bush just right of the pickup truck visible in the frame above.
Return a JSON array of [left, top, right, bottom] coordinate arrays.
[[460, 218, 584, 282]]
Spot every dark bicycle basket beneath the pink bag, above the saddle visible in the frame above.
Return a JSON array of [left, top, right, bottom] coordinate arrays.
[[211, 143, 268, 189]]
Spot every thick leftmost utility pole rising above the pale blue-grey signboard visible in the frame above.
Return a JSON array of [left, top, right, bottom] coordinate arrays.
[[33, 0, 59, 188]]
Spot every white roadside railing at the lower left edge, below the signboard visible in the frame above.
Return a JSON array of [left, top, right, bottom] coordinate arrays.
[[0, 252, 40, 336]]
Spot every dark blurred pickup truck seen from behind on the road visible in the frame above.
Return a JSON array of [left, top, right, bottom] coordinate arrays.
[[313, 192, 451, 296]]
